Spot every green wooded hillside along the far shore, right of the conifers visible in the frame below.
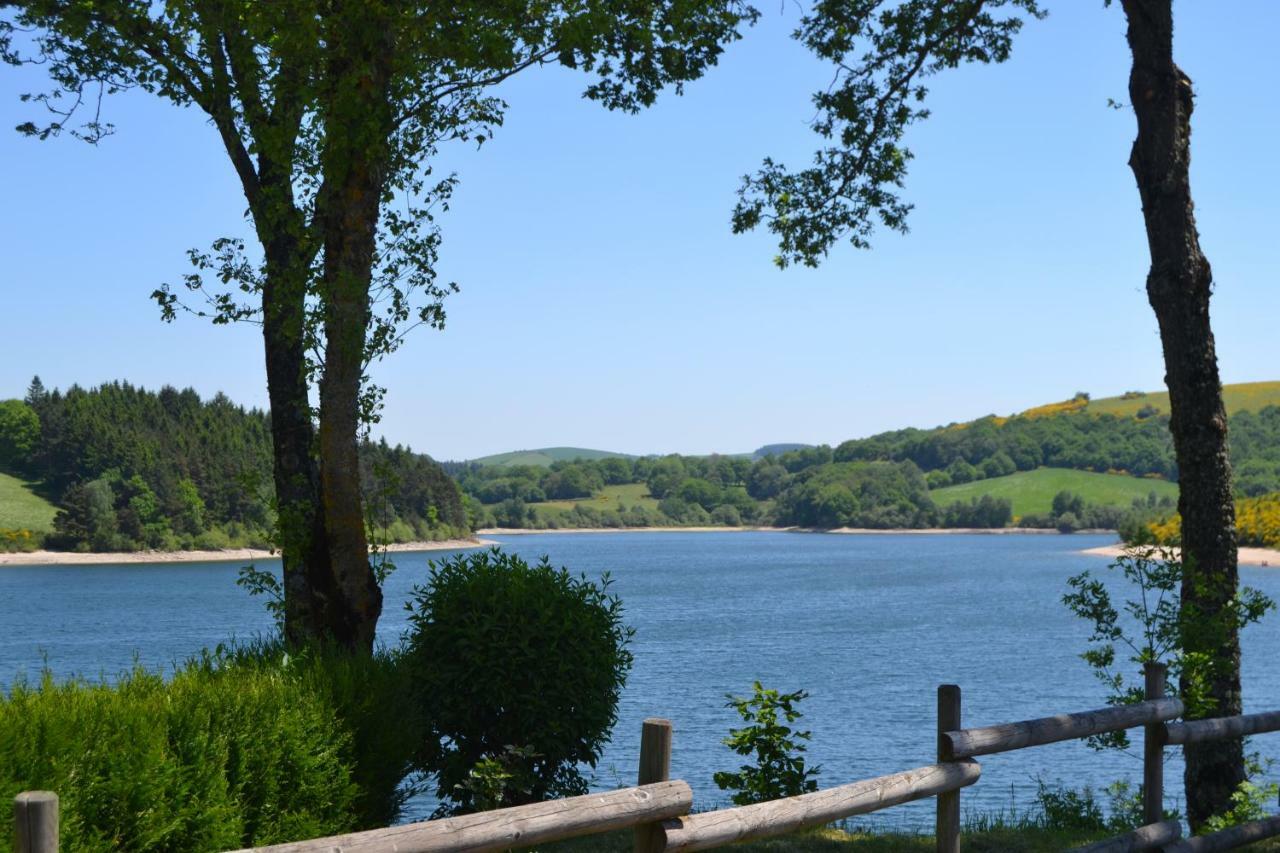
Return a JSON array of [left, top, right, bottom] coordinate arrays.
[[449, 407, 1198, 532]]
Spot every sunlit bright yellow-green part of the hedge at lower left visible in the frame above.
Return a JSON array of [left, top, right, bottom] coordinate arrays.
[[0, 657, 357, 850]]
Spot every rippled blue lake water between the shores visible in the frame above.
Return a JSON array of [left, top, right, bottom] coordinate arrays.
[[0, 533, 1280, 827]]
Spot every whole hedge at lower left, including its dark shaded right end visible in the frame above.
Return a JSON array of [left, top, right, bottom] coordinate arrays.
[[0, 644, 421, 852]]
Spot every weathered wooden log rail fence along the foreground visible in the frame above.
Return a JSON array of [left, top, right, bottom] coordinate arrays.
[[14, 663, 1280, 853]]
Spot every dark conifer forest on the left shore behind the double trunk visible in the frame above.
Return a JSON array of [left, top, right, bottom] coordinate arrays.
[[0, 378, 467, 551]]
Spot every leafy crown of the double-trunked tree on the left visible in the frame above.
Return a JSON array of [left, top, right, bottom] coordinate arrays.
[[0, 0, 756, 415]]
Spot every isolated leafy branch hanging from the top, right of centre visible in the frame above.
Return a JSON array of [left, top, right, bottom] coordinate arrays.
[[733, 0, 1044, 266]]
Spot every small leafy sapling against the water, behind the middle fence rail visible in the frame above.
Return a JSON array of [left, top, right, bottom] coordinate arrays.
[[714, 681, 820, 806]]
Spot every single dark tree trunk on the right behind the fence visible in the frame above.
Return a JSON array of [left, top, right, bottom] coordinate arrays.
[[1124, 0, 1244, 829]]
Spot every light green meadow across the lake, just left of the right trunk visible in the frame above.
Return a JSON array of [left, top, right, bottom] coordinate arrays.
[[929, 467, 1178, 516]]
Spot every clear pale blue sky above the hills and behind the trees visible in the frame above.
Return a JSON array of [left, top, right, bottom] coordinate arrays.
[[0, 0, 1280, 459]]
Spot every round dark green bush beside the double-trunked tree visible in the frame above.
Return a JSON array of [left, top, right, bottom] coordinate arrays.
[[404, 548, 631, 812]]
